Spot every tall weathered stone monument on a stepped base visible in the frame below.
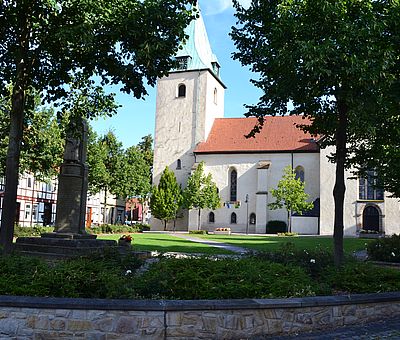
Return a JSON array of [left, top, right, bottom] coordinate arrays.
[[15, 120, 121, 257]]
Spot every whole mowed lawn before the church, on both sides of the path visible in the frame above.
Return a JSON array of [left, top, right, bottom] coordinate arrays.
[[99, 232, 371, 255]]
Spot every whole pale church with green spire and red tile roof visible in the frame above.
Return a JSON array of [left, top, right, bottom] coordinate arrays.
[[152, 8, 400, 236]]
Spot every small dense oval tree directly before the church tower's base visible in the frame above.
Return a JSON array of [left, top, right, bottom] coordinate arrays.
[[150, 167, 182, 230]]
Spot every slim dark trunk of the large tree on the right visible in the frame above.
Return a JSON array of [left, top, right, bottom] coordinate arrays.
[[333, 100, 348, 267]]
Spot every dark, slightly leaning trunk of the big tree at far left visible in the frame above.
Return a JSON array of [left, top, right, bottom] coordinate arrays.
[[0, 6, 31, 254]]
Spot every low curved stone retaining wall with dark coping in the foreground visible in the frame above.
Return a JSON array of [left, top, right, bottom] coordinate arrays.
[[0, 292, 400, 340]]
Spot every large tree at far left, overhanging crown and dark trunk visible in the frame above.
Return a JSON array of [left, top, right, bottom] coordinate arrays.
[[0, 0, 194, 253]]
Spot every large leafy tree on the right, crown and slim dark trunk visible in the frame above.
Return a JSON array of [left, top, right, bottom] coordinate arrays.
[[231, 0, 400, 265]]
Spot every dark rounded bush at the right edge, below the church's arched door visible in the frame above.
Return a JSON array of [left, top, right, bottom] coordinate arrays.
[[367, 235, 400, 263]]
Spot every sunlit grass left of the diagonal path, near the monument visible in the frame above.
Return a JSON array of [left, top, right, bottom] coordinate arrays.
[[98, 233, 232, 255]]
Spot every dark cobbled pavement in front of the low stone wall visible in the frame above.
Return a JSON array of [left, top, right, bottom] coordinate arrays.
[[268, 318, 400, 340]]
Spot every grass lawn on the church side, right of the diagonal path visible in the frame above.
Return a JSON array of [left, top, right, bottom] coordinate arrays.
[[192, 235, 371, 253]]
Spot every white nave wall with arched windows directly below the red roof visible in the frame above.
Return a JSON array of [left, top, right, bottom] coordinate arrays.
[[192, 153, 319, 233]]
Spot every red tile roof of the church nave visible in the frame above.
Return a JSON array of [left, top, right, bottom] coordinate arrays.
[[194, 116, 319, 153]]
